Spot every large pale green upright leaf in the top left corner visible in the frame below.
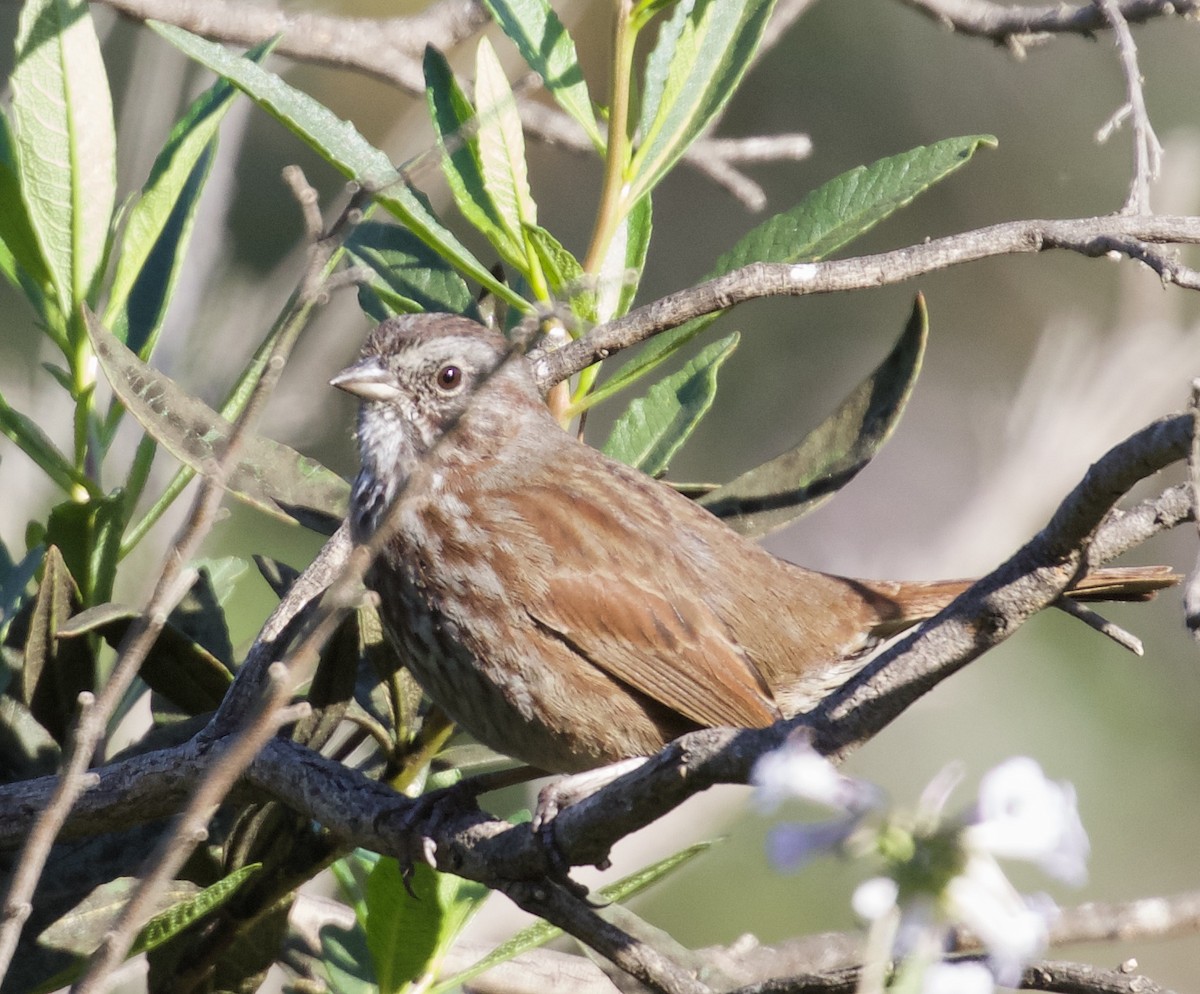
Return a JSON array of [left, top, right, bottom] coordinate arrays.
[[11, 0, 116, 315]]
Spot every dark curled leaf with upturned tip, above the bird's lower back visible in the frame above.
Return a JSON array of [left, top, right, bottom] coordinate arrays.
[[698, 294, 929, 537]]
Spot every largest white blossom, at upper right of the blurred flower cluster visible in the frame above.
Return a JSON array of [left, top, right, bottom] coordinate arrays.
[[962, 756, 1090, 886]]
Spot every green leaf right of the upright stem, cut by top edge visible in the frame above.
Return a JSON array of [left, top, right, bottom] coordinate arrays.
[[625, 0, 775, 204]]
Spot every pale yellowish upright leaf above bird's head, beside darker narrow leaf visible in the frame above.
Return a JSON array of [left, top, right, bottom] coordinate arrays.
[[474, 37, 538, 270]]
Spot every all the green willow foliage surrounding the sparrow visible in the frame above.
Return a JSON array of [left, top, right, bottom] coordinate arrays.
[[0, 0, 994, 990]]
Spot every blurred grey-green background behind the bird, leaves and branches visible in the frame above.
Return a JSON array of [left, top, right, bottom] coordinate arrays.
[[0, 0, 1200, 992]]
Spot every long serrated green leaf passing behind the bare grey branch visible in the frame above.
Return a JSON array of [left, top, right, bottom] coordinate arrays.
[[605, 134, 996, 395]]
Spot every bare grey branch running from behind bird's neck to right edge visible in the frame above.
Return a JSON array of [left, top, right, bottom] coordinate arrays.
[[529, 215, 1200, 389]]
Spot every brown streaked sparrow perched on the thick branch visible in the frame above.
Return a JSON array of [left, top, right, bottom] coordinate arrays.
[[332, 315, 1175, 772]]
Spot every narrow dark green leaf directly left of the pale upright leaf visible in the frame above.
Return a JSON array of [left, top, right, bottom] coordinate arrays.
[[424, 46, 524, 264]]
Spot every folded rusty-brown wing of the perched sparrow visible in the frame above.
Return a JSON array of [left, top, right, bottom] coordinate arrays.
[[486, 480, 780, 727]]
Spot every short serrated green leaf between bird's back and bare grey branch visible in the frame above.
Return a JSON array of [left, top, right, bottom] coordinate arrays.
[[604, 331, 739, 477]]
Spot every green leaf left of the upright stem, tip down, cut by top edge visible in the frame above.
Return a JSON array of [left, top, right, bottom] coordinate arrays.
[[484, 0, 604, 151]]
